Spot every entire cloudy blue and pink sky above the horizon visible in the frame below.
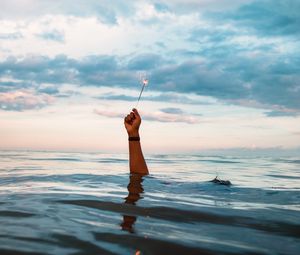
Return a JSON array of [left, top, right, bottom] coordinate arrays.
[[0, 0, 300, 153]]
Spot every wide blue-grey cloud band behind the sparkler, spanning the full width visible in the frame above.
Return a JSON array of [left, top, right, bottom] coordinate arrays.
[[0, 48, 300, 111]]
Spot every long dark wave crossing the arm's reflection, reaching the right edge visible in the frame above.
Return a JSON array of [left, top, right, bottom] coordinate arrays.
[[56, 200, 300, 238]]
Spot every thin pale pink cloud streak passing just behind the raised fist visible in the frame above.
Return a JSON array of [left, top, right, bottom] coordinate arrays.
[[94, 109, 199, 124]]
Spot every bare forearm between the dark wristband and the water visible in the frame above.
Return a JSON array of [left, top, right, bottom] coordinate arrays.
[[129, 134, 149, 175]]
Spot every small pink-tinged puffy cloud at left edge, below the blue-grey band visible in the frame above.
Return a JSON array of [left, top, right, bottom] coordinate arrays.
[[0, 90, 54, 111]]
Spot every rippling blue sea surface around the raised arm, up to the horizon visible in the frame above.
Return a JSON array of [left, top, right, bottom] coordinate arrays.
[[0, 151, 300, 255]]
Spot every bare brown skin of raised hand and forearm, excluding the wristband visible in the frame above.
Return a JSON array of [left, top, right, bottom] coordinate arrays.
[[124, 109, 149, 175]]
